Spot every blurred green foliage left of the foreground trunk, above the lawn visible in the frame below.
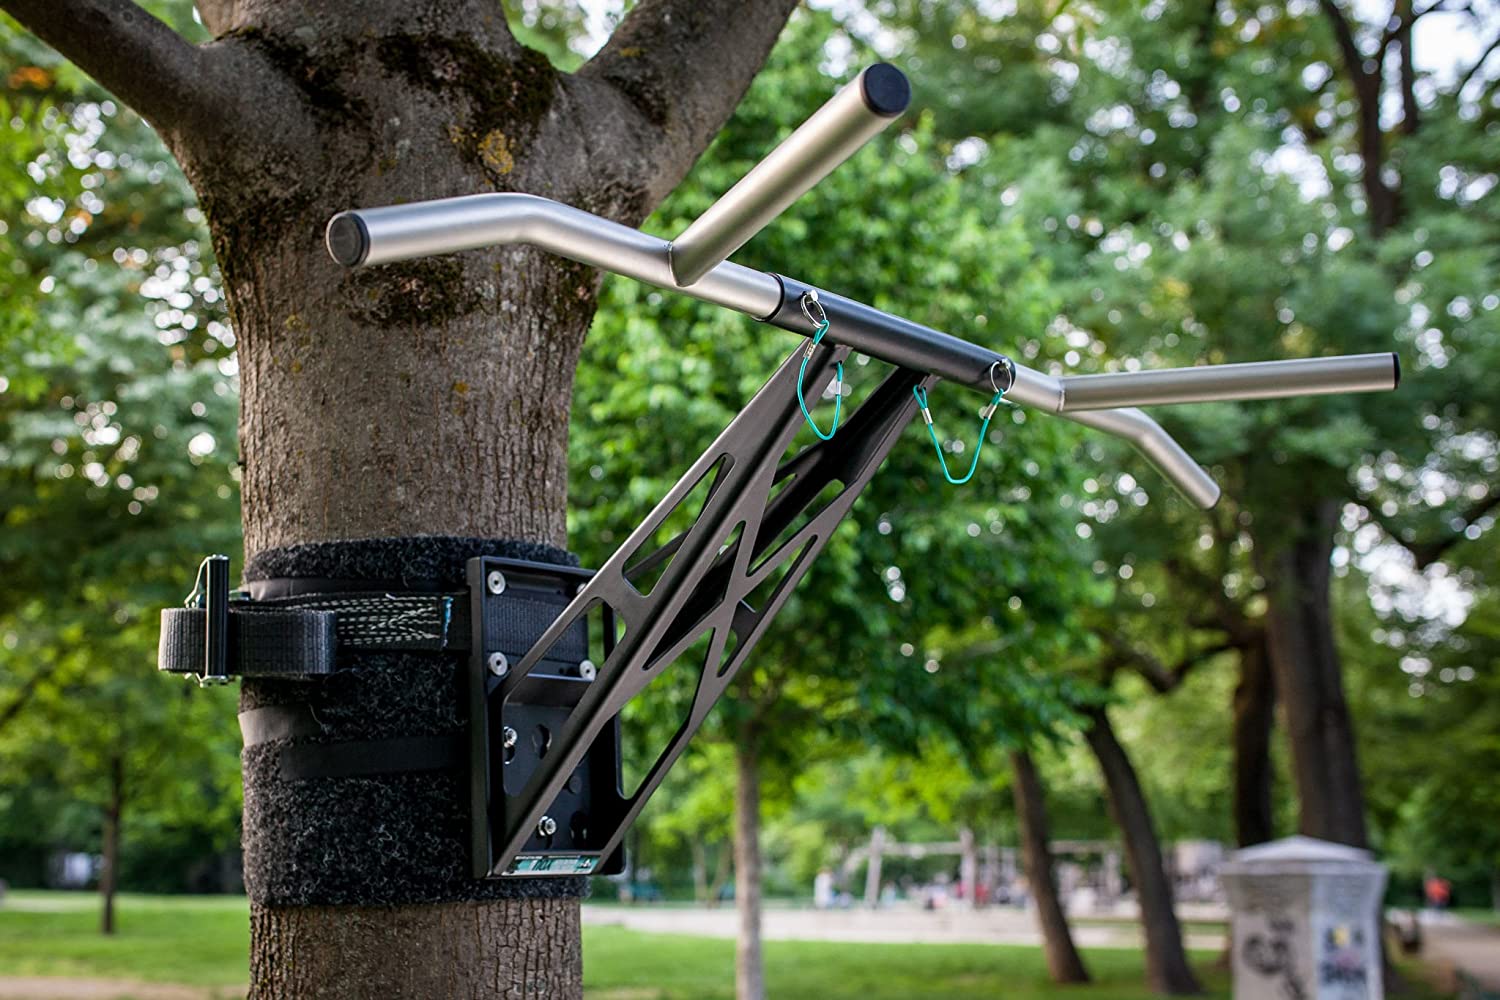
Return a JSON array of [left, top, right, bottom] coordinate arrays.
[[0, 4, 239, 885]]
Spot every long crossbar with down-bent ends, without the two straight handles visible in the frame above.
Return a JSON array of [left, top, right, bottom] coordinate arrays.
[[327, 193, 1218, 507]]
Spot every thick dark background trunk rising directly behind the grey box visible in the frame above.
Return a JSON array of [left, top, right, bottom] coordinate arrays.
[[1257, 501, 1368, 847]]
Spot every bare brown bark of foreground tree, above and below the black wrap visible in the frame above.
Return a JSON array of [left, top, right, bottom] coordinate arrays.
[[0, 0, 795, 997]]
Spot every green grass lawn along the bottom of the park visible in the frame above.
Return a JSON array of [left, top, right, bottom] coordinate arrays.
[[0, 891, 1440, 1000]]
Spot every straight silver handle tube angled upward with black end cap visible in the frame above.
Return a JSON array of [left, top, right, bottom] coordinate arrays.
[[671, 63, 912, 288]]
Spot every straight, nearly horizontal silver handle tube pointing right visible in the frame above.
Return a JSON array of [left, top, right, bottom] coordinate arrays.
[[1059, 354, 1401, 414]]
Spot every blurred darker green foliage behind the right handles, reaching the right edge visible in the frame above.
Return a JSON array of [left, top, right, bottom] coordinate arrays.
[[873, 0, 1500, 865]]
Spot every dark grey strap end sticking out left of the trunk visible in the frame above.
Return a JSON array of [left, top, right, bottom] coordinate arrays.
[[156, 607, 338, 678]]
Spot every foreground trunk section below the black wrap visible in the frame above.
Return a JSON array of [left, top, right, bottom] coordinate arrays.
[[251, 900, 584, 1000]]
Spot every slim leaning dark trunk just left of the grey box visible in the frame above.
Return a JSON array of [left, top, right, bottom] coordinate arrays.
[[1085, 708, 1203, 996]]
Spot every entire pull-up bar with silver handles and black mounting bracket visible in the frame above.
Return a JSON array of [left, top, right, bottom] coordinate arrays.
[[304, 64, 1400, 877]]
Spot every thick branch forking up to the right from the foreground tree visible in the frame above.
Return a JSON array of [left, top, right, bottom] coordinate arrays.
[[578, 0, 797, 214]]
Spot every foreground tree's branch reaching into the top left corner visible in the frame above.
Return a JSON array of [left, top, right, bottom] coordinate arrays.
[[0, 0, 221, 140]]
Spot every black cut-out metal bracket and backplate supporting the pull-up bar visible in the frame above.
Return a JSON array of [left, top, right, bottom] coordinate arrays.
[[470, 345, 936, 877]]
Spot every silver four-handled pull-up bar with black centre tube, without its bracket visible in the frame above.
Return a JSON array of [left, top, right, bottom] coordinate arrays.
[[327, 63, 1401, 508]]
